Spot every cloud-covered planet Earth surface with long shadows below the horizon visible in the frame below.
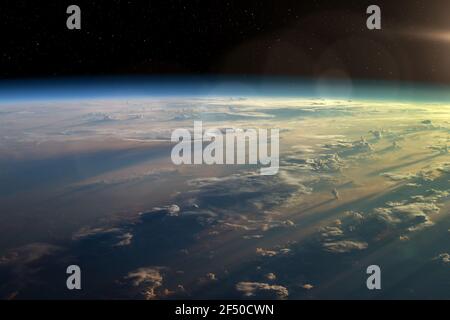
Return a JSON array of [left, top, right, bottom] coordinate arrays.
[[0, 79, 450, 299]]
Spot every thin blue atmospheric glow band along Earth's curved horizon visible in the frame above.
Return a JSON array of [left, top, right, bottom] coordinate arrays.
[[0, 76, 450, 103]]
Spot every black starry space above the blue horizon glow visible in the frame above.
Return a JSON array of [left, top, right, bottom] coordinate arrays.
[[0, 0, 450, 84]]
